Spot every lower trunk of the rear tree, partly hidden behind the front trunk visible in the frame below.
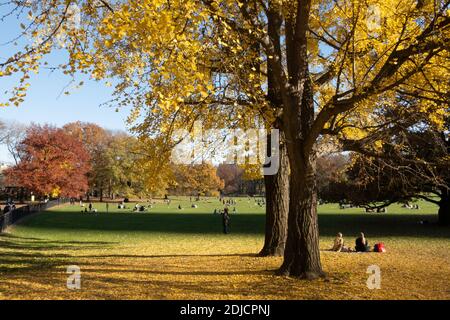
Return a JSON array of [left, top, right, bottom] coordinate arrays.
[[259, 135, 289, 256]]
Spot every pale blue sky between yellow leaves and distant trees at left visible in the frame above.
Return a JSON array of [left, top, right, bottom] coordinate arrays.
[[0, 8, 132, 162]]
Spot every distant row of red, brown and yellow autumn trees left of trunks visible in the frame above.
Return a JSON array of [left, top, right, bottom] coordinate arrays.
[[0, 122, 264, 201]]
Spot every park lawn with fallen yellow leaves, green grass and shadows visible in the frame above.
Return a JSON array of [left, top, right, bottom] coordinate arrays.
[[0, 198, 450, 299]]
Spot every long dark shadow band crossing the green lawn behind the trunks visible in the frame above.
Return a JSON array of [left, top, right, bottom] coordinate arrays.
[[13, 212, 450, 238]]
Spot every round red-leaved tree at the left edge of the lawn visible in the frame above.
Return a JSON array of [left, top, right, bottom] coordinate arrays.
[[5, 125, 90, 197]]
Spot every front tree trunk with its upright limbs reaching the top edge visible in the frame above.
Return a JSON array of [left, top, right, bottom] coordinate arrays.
[[268, 0, 324, 279]]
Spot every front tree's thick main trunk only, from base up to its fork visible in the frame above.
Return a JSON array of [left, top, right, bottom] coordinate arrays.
[[279, 67, 325, 279]]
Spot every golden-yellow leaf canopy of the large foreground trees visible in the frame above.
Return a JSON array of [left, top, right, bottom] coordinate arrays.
[[0, 0, 450, 156]]
